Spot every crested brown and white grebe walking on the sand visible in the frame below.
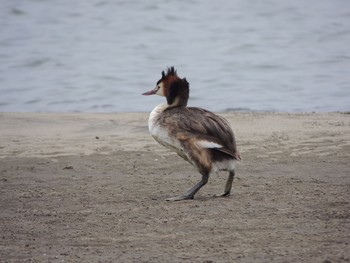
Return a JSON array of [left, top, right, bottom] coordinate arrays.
[[142, 67, 241, 201]]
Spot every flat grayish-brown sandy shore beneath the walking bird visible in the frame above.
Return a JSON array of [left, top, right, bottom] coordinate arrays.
[[0, 113, 350, 263]]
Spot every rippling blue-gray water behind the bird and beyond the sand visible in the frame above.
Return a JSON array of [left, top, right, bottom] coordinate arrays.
[[0, 0, 350, 112]]
